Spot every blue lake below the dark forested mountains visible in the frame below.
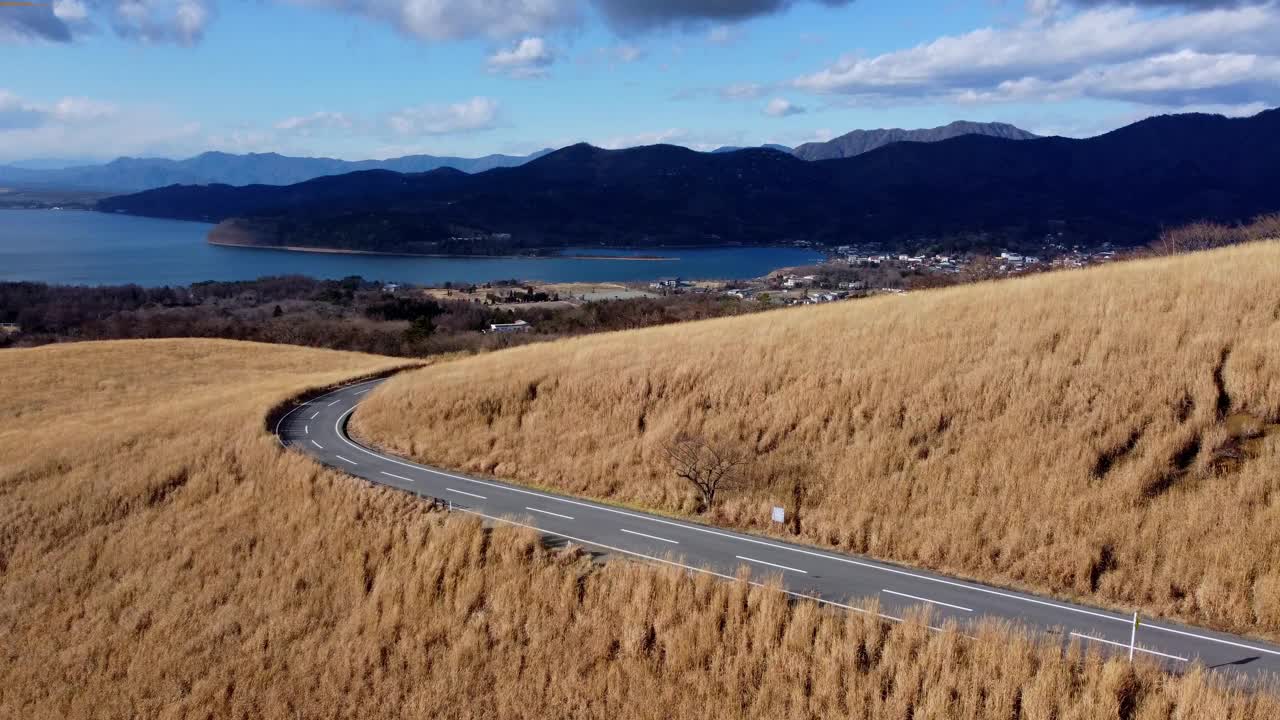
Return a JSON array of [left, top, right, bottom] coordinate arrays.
[[0, 210, 822, 286]]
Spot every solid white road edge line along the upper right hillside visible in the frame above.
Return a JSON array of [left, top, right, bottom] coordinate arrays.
[[325, 404, 1280, 657]]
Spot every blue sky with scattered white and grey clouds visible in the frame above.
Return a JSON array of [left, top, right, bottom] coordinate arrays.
[[0, 0, 1280, 161]]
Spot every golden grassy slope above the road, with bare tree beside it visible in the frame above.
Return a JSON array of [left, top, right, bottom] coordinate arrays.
[[356, 242, 1280, 637]]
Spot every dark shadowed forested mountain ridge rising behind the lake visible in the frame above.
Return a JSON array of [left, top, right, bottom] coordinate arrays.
[[99, 110, 1280, 252]]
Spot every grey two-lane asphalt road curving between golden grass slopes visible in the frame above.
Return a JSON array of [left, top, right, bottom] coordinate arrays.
[[275, 380, 1280, 679]]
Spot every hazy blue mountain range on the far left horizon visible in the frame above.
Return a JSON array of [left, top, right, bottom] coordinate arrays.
[[0, 150, 550, 192]]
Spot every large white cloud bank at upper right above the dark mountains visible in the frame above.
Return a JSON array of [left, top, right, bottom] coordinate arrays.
[[792, 4, 1280, 104]]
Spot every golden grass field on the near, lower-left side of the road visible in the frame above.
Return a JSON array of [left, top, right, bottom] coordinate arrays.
[[0, 341, 1280, 720]]
